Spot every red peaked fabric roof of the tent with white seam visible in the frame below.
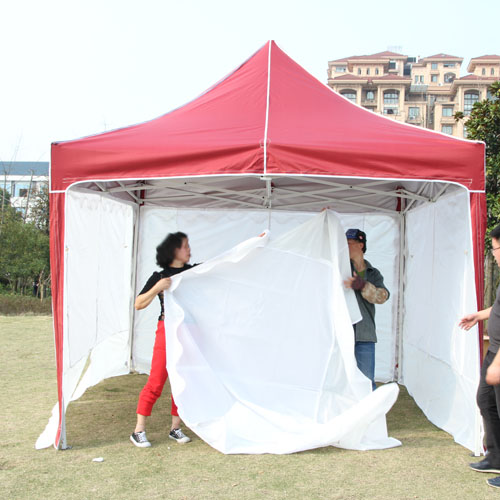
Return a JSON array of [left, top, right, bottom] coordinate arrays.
[[51, 42, 484, 191]]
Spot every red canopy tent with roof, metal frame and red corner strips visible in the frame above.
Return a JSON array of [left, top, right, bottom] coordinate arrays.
[[45, 42, 486, 447]]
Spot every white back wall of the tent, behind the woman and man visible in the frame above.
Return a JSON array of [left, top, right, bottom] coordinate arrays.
[[132, 207, 399, 382]]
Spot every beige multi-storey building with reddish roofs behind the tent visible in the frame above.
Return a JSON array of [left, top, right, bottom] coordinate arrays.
[[328, 51, 500, 137]]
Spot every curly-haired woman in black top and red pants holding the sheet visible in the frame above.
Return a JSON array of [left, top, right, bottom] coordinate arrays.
[[130, 232, 193, 448]]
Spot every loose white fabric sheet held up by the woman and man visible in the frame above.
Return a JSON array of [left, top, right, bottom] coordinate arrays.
[[165, 212, 400, 453]]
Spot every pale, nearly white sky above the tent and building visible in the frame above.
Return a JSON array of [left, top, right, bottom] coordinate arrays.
[[0, 0, 500, 162]]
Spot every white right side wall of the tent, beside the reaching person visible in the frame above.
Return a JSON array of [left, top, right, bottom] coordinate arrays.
[[402, 189, 482, 454]]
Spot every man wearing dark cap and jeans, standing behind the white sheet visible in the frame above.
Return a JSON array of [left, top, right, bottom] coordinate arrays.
[[344, 229, 389, 390]]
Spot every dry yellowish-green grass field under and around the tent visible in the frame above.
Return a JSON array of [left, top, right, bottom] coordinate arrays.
[[0, 316, 500, 500]]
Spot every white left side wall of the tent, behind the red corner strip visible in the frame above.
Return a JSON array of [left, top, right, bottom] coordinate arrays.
[[36, 189, 136, 448]]
